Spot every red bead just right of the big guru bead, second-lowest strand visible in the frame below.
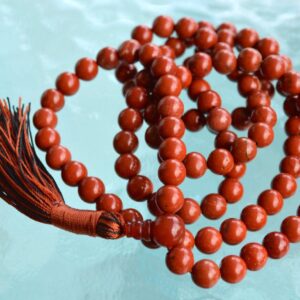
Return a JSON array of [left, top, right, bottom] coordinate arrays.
[[195, 227, 222, 254]]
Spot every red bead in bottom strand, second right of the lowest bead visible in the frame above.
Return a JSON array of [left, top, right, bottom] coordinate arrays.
[[240, 243, 268, 271]]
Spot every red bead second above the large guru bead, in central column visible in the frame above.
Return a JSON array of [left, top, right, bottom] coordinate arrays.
[[158, 159, 186, 185]]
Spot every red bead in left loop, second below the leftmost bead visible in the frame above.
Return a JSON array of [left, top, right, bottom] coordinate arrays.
[[46, 145, 71, 170]]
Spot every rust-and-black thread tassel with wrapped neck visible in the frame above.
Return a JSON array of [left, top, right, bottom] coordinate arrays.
[[0, 99, 125, 239]]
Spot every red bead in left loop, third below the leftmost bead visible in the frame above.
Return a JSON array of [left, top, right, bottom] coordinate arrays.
[[61, 161, 87, 186]]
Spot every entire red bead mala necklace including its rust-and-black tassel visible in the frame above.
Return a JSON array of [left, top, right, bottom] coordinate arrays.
[[0, 16, 300, 288]]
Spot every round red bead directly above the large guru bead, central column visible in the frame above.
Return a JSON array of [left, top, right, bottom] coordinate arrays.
[[156, 185, 184, 214]]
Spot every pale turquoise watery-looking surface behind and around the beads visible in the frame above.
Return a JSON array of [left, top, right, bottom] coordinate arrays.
[[0, 0, 300, 300]]
